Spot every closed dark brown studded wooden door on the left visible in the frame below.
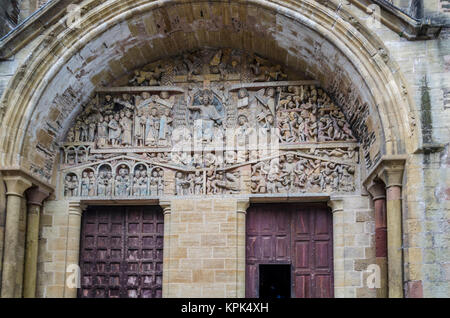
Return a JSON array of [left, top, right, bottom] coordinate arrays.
[[79, 206, 164, 298]]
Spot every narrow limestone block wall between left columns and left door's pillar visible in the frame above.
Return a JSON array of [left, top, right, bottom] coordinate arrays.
[[36, 201, 69, 298]]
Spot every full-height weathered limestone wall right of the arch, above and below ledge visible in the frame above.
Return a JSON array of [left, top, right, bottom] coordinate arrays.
[[338, 0, 450, 297]]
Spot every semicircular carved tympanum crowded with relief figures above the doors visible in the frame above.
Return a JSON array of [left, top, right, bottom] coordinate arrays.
[[61, 49, 362, 199]]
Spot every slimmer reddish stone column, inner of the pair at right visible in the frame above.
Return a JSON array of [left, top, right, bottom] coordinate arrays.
[[367, 182, 388, 298]]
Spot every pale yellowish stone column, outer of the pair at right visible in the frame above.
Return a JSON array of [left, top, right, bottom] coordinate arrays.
[[379, 163, 403, 298]]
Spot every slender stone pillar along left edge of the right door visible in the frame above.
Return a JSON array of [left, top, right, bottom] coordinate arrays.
[[236, 198, 250, 298]]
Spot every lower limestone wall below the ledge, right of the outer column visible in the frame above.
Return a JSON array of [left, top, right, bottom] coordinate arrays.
[[403, 150, 450, 297]]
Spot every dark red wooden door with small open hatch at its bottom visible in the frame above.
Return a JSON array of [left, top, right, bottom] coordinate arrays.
[[246, 204, 334, 298]]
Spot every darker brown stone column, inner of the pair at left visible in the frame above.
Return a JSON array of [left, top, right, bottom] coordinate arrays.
[[23, 187, 50, 298]]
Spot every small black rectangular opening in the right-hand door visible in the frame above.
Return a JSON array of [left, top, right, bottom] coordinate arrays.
[[259, 264, 291, 298]]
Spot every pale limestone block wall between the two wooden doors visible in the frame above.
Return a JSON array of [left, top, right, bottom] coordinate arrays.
[[163, 199, 245, 298]]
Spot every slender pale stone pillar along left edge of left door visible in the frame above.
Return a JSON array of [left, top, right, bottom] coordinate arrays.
[[64, 201, 85, 298]]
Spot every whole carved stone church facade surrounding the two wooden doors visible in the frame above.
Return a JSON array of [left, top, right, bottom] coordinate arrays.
[[0, 0, 450, 297]]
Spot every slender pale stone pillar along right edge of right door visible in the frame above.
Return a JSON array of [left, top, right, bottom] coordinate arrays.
[[328, 198, 345, 298]]
